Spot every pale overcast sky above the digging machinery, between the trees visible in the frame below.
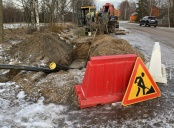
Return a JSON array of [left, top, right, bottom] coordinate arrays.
[[94, 0, 137, 9]]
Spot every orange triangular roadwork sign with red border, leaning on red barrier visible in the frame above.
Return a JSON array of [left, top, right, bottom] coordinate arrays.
[[122, 58, 161, 106]]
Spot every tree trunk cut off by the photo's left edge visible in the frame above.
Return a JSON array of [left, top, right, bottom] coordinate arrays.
[[0, 0, 4, 44]]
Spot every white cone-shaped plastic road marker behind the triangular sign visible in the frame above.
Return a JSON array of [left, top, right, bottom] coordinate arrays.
[[146, 42, 167, 83]]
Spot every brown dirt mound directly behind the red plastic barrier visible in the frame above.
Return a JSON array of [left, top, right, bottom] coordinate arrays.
[[90, 35, 145, 60]]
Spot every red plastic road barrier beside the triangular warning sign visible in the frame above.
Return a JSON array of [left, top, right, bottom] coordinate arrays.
[[75, 54, 137, 108]]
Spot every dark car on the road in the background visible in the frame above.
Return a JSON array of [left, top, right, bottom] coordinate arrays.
[[140, 16, 158, 27]]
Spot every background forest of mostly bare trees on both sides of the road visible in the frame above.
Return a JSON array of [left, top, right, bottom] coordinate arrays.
[[0, 0, 174, 42]]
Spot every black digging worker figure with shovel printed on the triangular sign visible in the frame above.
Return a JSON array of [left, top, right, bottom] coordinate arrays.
[[134, 72, 155, 97]]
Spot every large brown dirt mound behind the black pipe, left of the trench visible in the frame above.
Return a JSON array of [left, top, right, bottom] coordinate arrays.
[[9, 32, 72, 65]]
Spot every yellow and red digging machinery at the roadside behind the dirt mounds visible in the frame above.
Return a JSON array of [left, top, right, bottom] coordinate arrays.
[[78, 3, 119, 35]]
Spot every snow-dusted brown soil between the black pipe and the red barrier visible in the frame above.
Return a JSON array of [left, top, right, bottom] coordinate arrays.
[[13, 69, 85, 105]]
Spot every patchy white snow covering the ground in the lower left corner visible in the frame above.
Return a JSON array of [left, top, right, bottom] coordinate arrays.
[[0, 87, 66, 128]]
